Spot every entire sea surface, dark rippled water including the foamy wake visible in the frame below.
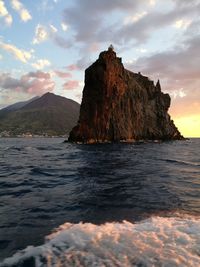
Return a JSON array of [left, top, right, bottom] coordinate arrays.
[[0, 138, 200, 267]]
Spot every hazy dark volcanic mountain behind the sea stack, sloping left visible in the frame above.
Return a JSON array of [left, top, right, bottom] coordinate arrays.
[[0, 93, 80, 136]]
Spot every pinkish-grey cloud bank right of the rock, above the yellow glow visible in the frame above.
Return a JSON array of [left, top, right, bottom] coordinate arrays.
[[129, 36, 200, 117]]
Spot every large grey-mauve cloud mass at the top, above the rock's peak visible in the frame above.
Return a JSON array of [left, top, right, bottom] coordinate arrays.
[[63, 0, 200, 47]]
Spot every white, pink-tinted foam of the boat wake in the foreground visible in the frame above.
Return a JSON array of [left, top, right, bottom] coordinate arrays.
[[0, 215, 200, 267]]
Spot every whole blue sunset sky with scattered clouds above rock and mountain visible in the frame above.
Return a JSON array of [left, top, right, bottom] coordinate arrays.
[[0, 0, 200, 137]]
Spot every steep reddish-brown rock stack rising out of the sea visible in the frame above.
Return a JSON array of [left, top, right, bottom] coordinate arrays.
[[69, 49, 183, 143]]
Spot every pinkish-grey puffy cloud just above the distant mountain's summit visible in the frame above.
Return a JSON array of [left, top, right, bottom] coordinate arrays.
[[0, 71, 55, 95]]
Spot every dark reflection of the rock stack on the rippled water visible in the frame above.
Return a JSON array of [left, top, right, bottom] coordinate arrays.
[[75, 145, 181, 223]]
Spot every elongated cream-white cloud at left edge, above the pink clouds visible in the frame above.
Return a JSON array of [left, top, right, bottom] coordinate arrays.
[[0, 41, 32, 63]]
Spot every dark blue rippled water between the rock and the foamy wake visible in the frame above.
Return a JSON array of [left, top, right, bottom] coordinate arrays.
[[0, 138, 200, 266]]
